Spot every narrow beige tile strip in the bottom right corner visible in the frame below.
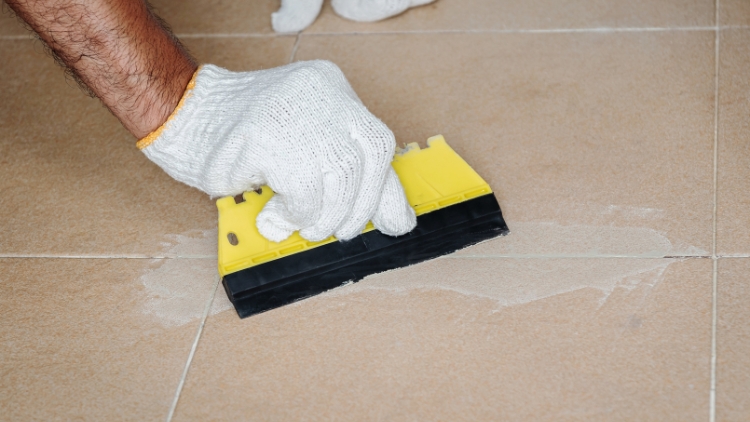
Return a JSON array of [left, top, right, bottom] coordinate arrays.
[[716, 259, 750, 422]]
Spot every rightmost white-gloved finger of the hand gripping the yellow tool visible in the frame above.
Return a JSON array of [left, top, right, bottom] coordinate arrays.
[[372, 168, 417, 236]]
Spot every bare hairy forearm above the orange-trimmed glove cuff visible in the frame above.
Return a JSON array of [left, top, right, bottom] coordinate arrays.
[[5, 0, 196, 138]]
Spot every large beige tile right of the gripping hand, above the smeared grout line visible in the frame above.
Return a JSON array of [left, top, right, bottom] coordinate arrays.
[[296, 31, 714, 256]]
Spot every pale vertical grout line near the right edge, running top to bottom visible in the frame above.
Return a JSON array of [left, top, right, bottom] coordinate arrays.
[[708, 0, 721, 422]]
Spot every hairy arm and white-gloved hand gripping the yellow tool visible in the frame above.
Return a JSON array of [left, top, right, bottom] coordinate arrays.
[[6, 0, 416, 241]]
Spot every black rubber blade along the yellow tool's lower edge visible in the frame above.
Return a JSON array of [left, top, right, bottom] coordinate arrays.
[[223, 194, 508, 318]]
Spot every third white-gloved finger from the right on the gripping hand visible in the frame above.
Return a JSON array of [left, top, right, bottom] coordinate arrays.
[[300, 142, 362, 242]]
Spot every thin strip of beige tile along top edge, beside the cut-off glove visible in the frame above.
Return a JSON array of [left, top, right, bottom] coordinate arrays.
[[306, 0, 715, 33]]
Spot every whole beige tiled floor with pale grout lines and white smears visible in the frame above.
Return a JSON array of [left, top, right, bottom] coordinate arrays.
[[0, 0, 750, 421]]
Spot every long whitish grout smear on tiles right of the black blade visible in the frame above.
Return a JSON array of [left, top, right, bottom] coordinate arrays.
[[322, 223, 701, 308]]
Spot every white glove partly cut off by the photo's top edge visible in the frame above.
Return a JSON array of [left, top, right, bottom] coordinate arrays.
[[271, 0, 435, 32]]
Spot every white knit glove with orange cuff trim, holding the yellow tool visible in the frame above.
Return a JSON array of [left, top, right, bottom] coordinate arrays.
[[138, 61, 416, 242]]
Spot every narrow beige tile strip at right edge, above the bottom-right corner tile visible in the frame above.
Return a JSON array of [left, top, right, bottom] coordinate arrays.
[[716, 29, 750, 255]]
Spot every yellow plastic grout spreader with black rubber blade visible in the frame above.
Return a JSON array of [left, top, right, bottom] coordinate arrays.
[[217, 136, 508, 318]]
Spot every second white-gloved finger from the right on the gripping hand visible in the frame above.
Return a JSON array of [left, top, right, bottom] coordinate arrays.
[[336, 118, 396, 240]]
